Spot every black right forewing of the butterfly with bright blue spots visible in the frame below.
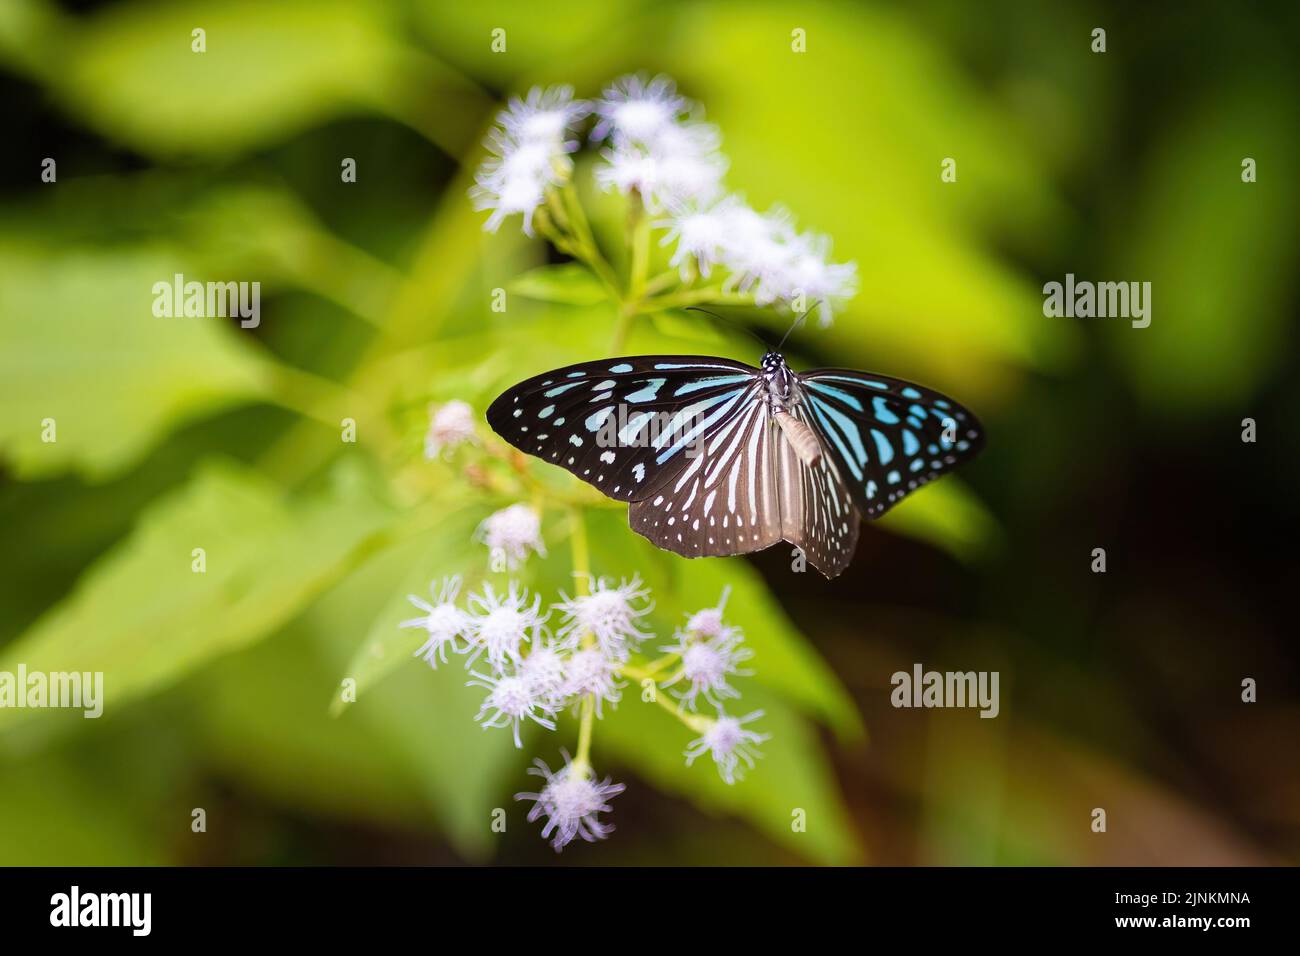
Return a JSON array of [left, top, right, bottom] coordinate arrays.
[[796, 368, 984, 518]]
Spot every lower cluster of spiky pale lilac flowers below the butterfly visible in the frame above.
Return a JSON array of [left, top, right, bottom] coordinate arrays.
[[402, 505, 768, 851]]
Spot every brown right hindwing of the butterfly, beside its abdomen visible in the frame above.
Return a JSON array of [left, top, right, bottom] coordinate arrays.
[[772, 403, 862, 578]]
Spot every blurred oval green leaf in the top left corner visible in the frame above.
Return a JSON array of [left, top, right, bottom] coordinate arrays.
[[31, 0, 399, 157]]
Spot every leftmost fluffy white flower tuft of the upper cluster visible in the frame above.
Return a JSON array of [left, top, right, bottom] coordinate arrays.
[[469, 86, 589, 235]]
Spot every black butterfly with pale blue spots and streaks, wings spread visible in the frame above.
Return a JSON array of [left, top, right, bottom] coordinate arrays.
[[488, 351, 984, 578]]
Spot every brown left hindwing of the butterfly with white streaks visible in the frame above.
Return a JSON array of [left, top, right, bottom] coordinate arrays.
[[628, 377, 784, 558]]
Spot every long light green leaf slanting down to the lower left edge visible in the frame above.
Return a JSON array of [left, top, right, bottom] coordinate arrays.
[[0, 464, 390, 728]]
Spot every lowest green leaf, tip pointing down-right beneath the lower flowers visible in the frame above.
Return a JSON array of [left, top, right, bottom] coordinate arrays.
[[593, 686, 863, 864]]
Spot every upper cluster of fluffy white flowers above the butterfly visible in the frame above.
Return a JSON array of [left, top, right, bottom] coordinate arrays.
[[472, 75, 857, 324]]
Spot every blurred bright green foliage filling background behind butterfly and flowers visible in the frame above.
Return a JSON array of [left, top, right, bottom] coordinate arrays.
[[0, 0, 1300, 864]]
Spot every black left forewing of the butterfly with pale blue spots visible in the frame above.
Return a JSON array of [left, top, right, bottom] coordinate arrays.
[[488, 355, 762, 504]]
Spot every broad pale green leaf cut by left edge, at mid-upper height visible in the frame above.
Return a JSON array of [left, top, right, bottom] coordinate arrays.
[[0, 241, 267, 479]]
